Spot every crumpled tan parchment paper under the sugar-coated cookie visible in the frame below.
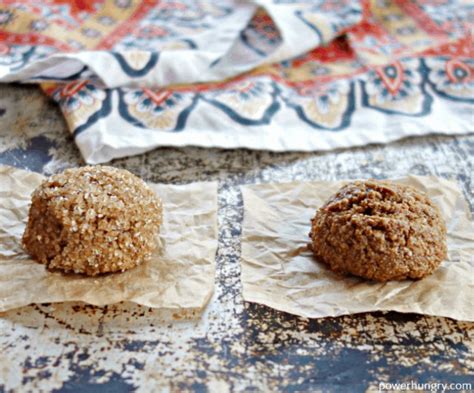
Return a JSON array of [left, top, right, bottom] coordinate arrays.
[[0, 166, 217, 311]]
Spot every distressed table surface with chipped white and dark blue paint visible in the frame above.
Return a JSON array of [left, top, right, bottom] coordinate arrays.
[[0, 85, 474, 392]]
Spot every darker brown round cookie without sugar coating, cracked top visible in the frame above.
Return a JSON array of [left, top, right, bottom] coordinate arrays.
[[309, 180, 447, 281]]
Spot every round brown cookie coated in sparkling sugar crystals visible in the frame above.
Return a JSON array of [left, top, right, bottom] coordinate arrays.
[[23, 166, 162, 276]]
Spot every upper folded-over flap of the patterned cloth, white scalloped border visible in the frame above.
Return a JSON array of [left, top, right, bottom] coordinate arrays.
[[0, 0, 361, 88]]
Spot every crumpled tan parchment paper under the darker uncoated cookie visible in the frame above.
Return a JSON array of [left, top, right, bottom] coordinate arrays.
[[241, 176, 474, 321]]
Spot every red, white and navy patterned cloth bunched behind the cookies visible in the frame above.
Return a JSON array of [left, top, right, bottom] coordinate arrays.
[[0, 0, 474, 163]]
